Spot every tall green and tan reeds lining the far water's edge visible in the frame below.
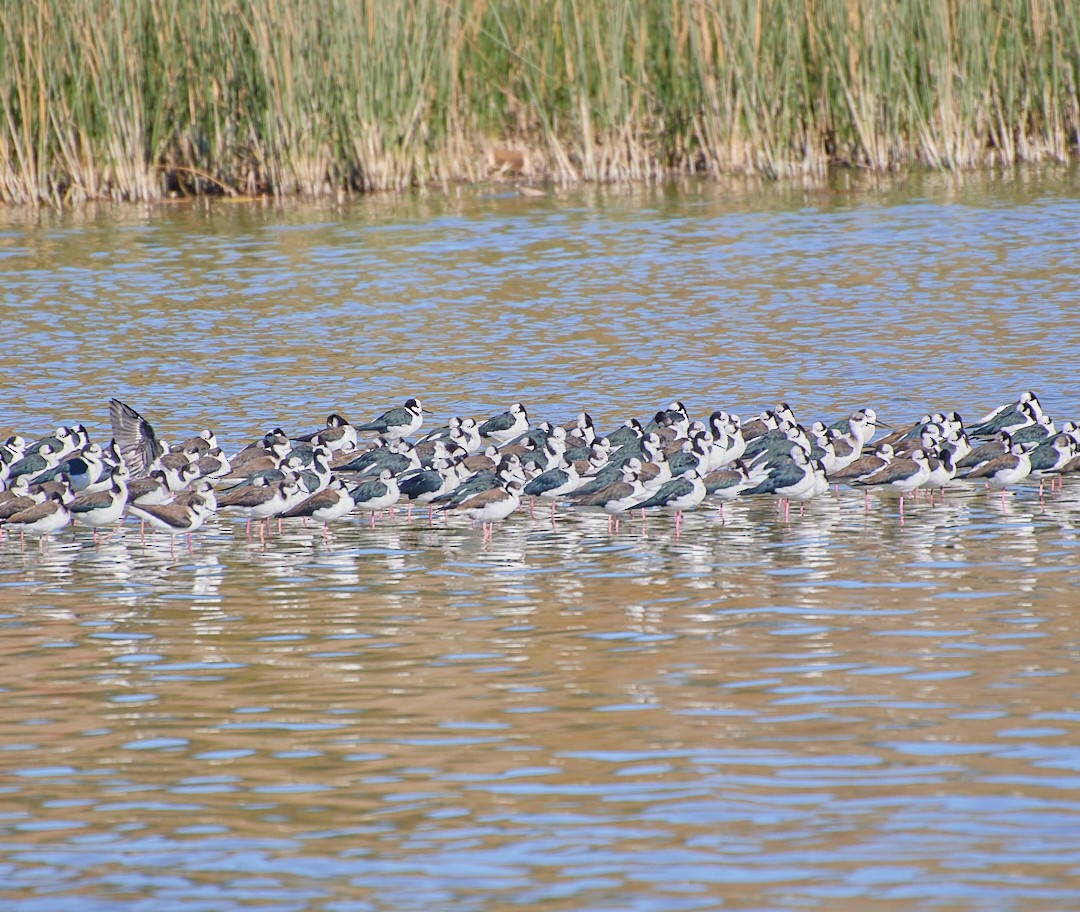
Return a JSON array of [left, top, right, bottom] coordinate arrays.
[[0, 0, 1080, 204]]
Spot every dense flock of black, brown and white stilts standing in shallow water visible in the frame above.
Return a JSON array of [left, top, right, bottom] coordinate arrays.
[[0, 392, 1080, 547]]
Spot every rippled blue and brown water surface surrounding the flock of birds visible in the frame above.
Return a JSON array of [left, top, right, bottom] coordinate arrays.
[[0, 174, 1080, 912]]
